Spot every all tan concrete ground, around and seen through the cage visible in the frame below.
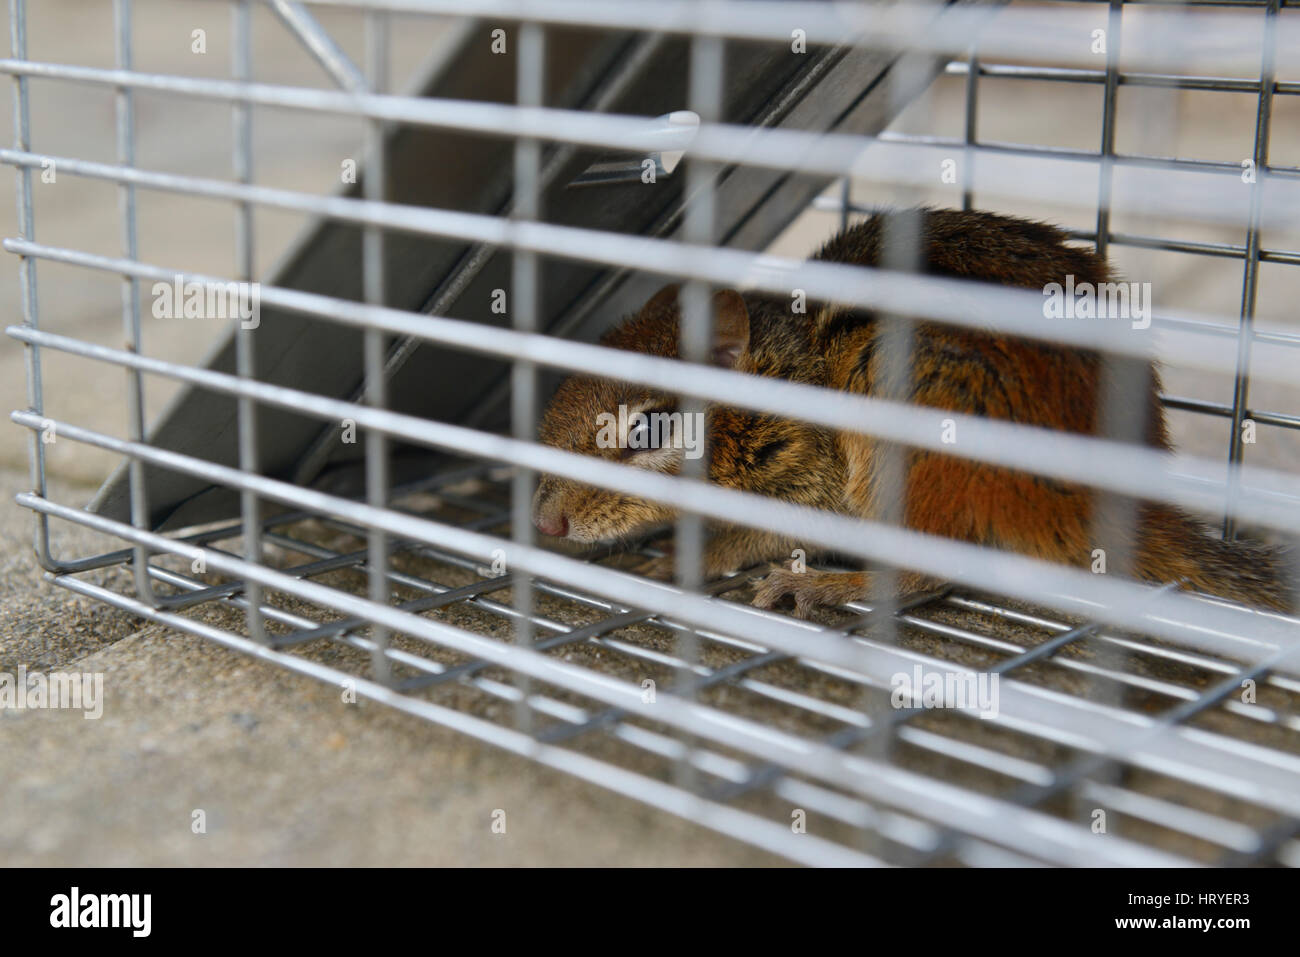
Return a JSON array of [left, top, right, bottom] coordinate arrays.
[[0, 0, 1300, 865]]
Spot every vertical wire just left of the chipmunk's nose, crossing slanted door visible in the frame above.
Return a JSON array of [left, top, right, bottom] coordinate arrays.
[[510, 22, 546, 735]]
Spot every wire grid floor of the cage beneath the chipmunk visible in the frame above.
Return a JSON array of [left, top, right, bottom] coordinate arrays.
[[30, 465, 1300, 865]]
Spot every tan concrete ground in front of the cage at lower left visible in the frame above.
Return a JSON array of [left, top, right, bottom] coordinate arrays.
[[0, 469, 775, 866]]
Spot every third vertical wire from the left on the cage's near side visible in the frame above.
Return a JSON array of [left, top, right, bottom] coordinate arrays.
[[230, 0, 267, 642]]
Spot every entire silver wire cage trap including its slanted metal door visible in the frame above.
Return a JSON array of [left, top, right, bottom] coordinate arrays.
[[0, 0, 1300, 866]]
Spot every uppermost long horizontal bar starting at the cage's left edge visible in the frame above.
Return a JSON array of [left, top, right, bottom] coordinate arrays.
[[0, 59, 1300, 231]]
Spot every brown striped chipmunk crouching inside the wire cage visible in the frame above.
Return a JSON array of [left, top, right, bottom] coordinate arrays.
[[533, 209, 1292, 616]]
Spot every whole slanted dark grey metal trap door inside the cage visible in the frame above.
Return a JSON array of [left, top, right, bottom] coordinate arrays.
[[92, 1, 982, 528]]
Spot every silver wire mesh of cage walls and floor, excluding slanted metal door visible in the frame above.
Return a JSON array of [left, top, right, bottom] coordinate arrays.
[[0, 0, 1300, 866]]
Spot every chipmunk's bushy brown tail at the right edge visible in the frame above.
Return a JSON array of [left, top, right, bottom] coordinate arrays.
[[1135, 505, 1300, 611]]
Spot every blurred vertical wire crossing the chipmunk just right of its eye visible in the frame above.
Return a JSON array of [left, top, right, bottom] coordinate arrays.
[[675, 29, 725, 791]]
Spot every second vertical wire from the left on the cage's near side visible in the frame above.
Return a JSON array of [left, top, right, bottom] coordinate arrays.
[[113, 0, 159, 606]]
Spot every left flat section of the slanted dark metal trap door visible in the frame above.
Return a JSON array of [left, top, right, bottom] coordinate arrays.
[[91, 23, 628, 528]]
